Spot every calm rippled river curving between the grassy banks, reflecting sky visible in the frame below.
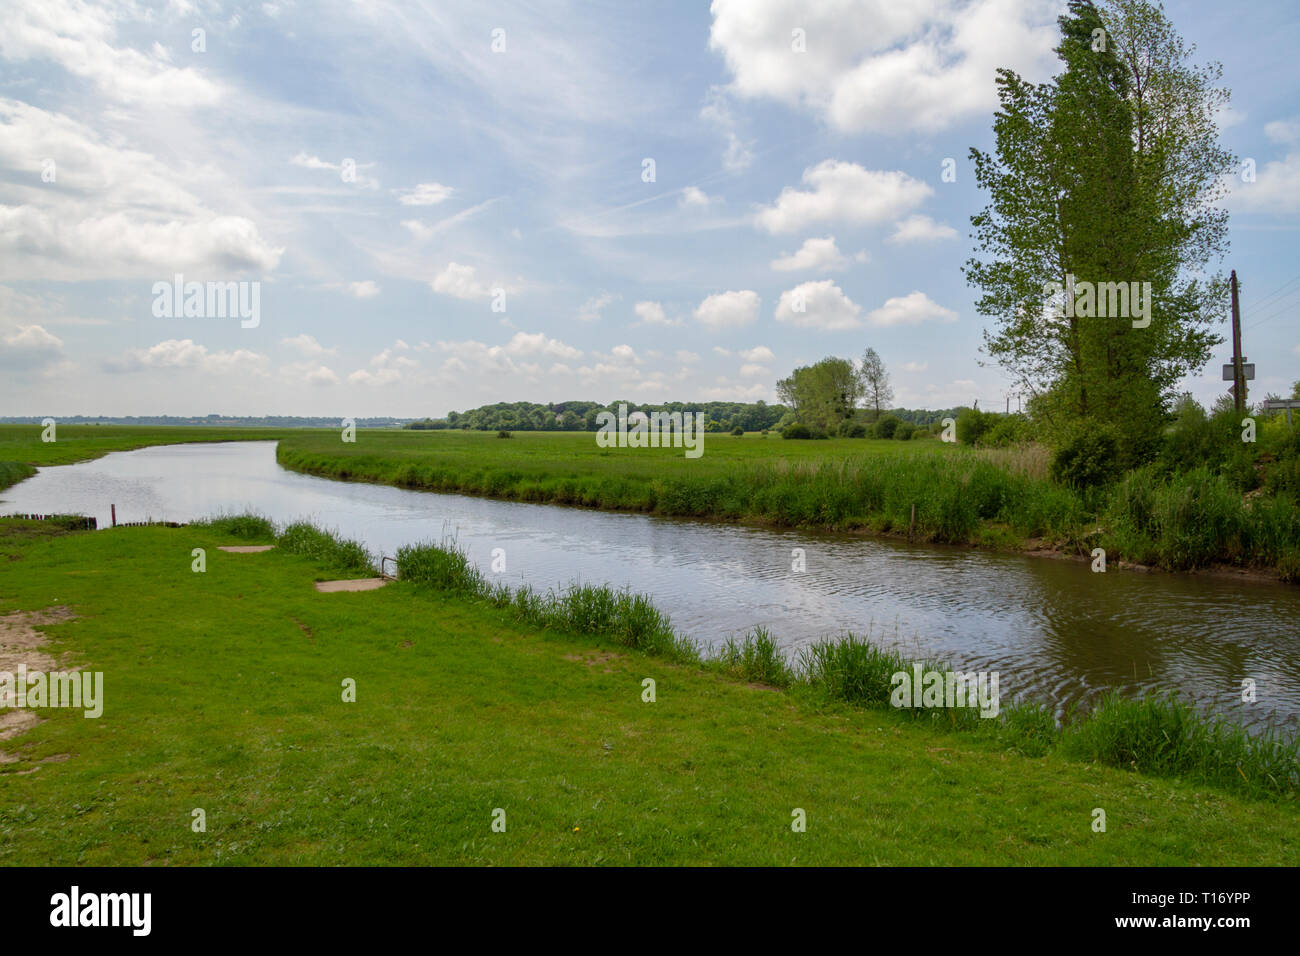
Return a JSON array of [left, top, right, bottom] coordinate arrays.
[[0, 441, 1300, 734]]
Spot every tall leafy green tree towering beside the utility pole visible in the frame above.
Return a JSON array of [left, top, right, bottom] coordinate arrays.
[[966, 0, 1232, 460]]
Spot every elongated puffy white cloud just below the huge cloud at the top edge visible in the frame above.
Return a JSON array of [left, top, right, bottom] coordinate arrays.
[[755, 160, 935, 233]]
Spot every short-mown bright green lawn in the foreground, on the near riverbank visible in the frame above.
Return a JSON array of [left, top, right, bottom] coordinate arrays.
[[0, 522, 1300, 865]]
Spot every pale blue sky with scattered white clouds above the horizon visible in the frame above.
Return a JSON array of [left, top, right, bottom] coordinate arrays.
[[0, 0, 1300, 418]]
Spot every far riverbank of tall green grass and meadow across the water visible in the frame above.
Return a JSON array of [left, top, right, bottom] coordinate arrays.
[[277, 431, 1300, 581]]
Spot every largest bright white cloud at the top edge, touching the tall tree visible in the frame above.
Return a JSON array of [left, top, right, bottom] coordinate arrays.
[[709, 0, 1058, 134]]
